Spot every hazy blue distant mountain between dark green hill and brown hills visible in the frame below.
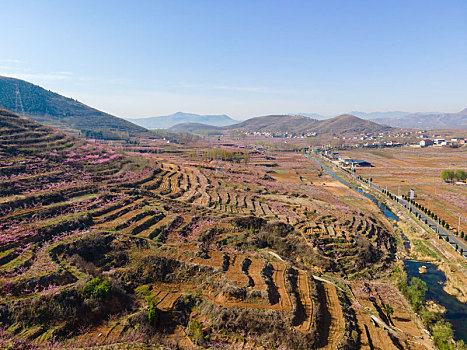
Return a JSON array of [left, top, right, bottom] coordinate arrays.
[[129, 112, 238, 129]]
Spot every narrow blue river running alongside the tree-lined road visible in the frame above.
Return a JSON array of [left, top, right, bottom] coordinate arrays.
[[305, 154, 467, 342]]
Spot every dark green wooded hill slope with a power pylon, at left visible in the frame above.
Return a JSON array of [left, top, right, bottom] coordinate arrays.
[[0, 76, 148, 138]]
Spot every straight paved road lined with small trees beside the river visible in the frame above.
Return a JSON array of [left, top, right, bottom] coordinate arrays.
[[314, 155, 467, 259]]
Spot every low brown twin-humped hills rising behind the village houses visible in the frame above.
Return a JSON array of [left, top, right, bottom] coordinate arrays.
[[169, 114, 392, 134]]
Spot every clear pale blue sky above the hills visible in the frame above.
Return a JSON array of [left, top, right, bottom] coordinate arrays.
[[0, 0, 467, 119]]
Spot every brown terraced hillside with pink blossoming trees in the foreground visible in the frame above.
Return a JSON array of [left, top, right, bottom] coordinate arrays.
[[0, 111, 434, 349]]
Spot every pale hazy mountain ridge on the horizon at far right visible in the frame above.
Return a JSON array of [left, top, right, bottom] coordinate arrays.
[[375, 108, 467, 130]]
